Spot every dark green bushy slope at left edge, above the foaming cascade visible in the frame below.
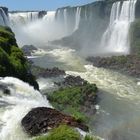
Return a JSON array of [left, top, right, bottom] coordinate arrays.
[[0, 26, 38, 89]]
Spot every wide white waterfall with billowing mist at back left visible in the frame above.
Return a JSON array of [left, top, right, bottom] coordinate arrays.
[[9, 11, 68, 46]]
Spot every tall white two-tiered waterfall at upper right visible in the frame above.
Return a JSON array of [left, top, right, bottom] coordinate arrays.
[[100, 0, 136, 54]]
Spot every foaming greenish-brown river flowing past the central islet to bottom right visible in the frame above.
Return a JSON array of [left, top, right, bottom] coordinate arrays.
[[30, 48, 140, 140]]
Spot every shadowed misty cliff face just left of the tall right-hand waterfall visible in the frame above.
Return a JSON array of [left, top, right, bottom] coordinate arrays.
[[54, 1, 113, 51]]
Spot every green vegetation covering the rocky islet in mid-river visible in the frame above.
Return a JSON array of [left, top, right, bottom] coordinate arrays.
[[48, 83, 97, 121]]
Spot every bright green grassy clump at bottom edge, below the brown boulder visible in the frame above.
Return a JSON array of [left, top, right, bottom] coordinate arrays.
[[35, 125, 81, 140]]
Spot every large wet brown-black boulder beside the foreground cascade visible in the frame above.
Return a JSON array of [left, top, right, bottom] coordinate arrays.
[[21, 107, 88, 136]]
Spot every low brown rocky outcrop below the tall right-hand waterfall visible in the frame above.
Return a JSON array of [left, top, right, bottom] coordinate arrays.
[[87, 55, 140, 78]]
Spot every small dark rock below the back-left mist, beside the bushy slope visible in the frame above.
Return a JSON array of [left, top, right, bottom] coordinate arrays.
[[21, 45, 37, 56]]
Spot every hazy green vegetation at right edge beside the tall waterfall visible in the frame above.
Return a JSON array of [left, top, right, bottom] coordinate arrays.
[[130, 19, 140, 54]]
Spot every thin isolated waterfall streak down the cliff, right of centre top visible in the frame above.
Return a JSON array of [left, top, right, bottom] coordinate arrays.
[[74, 7, 81, 31]]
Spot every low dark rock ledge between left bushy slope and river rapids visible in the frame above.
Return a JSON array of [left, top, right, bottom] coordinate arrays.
[[31, 65, 65, 78]]
